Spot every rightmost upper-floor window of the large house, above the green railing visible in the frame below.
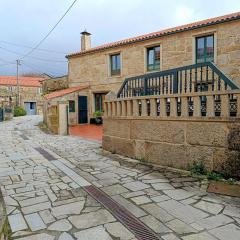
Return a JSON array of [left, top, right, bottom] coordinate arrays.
[[196, 35, 214, 63]]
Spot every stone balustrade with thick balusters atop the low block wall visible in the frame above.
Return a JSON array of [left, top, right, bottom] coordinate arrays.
[[104, 90, 240, 120]]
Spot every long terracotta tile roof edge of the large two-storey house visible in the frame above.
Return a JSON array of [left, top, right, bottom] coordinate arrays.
[[66, 12, 240, 57]]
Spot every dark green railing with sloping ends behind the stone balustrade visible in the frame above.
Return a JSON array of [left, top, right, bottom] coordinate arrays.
[[117, 62, 239, 98]]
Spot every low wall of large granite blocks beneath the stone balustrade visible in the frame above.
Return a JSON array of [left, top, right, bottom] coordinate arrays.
[[103, 117, 240, 177]]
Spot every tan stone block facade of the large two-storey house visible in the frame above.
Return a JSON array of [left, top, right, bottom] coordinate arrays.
[[68, 20, 240, 123]]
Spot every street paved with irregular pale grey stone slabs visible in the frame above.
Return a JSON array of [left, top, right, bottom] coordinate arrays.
[[0, 116, 240, 240]]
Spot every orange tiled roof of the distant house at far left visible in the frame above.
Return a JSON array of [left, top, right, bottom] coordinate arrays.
[[0, 76, 44, 87]]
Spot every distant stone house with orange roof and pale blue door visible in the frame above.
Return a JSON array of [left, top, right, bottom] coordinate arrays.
[[0, 76, 44, 115]]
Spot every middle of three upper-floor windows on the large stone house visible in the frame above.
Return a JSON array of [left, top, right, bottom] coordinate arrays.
[[147, 46, 160, 71]]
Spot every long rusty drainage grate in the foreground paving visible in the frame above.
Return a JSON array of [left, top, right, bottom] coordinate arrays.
[[84, 185, 161, 240]]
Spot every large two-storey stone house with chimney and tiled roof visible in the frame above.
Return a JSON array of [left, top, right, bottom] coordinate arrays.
[[44, 13, 240, 125]]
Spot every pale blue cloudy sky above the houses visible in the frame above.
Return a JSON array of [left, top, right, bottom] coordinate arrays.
[[0, 0, 240, 76]]
